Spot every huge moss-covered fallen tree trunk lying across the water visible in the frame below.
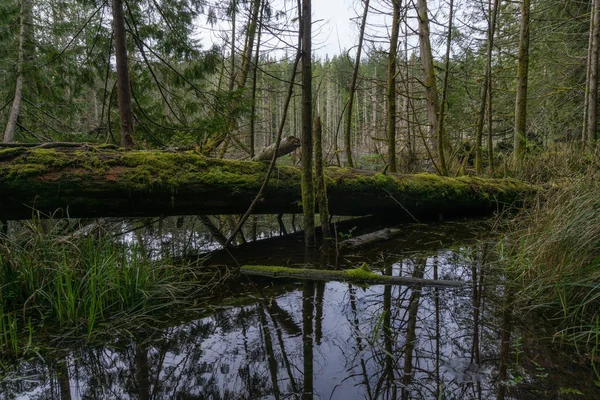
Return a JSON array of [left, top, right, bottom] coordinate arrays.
[[0, 147, 534, 220]]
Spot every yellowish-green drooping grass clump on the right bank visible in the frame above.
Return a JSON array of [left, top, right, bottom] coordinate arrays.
[[509, 179, 600, 354]]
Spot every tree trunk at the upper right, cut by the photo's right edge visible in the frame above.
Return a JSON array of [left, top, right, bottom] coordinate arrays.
[[586, 0, 600, 146]]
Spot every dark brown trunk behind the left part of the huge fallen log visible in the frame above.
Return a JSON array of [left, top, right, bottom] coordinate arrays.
[[112, 0, 134, 148]]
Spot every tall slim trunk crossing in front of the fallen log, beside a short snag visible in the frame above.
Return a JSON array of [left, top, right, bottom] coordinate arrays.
[[300, 0, 315, 246]]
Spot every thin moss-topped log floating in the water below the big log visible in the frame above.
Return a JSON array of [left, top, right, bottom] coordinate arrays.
[[241, 264, 465, 287]]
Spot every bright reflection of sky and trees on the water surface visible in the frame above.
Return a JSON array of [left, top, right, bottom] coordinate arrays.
[[0, 239, 597, 400]]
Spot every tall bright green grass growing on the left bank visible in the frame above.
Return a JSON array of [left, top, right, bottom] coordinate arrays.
[[0, 222, 217, 354]]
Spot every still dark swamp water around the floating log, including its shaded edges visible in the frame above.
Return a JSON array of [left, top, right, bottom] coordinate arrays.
[[0, 217, 600, 400]]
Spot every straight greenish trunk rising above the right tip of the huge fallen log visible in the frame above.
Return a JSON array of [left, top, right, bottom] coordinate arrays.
[[513, 0, 531, 164]]
